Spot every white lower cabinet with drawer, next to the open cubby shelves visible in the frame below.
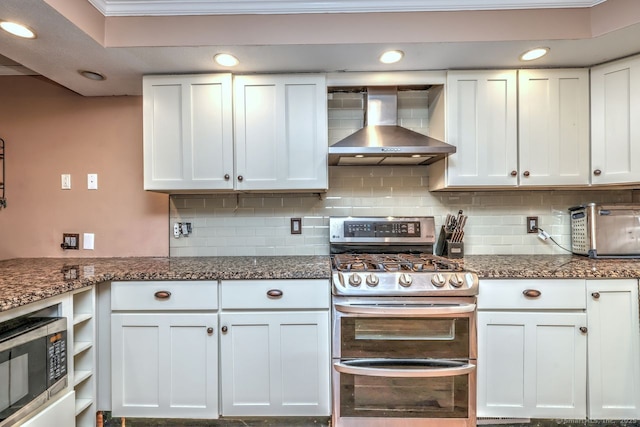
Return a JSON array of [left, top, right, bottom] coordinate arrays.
[[111, 281, 219, 419]]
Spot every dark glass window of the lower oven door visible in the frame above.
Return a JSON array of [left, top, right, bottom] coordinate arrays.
[[340, 366, 469, 418]]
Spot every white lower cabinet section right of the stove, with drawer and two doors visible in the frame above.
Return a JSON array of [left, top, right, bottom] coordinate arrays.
[[478, 279, 640, 420]]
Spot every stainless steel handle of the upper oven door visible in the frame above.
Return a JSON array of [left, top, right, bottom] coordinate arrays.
[[334, 304, 476, 317]]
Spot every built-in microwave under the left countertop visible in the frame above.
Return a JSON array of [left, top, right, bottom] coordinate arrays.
[[0, 316, 67, 427]]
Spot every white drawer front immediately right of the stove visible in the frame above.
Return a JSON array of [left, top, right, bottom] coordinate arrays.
[[478, 279, 586, 310]]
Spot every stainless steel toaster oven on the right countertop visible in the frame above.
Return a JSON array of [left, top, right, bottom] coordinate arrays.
[[569, 203, 640, 258]]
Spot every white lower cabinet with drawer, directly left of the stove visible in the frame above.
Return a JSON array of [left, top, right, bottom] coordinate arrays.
[[220, 280, 331, 417]]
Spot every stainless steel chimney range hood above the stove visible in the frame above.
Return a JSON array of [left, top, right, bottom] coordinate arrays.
[[329, 86, 456, 166]]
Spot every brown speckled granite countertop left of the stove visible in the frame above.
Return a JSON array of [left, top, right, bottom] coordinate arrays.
[[0, 256, 331, 312]]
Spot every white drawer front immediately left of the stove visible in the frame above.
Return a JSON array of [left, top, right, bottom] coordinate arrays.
[[220, 279, 331, 309]]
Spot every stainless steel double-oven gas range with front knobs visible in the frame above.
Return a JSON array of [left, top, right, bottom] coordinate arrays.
[[329, 217, 478, 427]]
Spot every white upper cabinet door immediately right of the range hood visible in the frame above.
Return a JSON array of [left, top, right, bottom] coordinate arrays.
[[446, 70, 518, 187]]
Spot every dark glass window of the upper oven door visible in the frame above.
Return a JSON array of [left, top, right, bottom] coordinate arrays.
[[340, 317, 469, 359]]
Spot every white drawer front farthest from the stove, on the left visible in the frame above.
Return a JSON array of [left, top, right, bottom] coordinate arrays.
[[111, 280, 218, 311]]
